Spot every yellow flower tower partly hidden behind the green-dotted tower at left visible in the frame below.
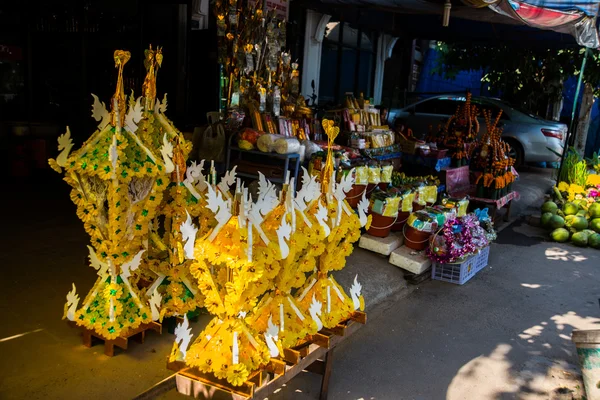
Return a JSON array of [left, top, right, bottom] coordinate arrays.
[[138, 46, 209, 320]]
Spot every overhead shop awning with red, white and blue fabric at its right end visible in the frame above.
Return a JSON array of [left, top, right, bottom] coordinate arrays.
[[296, 0, 600, 47]]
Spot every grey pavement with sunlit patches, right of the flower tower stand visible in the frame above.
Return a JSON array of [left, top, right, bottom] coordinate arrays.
[[236, 224, 600, 400]]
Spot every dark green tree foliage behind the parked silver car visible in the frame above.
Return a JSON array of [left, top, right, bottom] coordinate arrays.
[[433, 42, 600, 113]]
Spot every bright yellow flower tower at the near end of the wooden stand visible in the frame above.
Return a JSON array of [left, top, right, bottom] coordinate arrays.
[[178, 183, 281, 386]]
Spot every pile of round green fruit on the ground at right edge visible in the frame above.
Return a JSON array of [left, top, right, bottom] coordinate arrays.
[[541, 201, 600, 249]]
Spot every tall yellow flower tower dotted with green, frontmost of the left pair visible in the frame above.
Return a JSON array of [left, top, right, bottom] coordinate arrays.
[[50, 50, 170, 339]]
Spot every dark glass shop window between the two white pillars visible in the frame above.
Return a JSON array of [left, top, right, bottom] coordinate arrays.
[[319, 21, 376, 104]]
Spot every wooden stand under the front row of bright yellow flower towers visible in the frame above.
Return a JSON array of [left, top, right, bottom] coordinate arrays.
[[167, 311, 367, 400]]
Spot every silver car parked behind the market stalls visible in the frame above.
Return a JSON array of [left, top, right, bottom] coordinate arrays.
[[388, 95, 567, 165]]
